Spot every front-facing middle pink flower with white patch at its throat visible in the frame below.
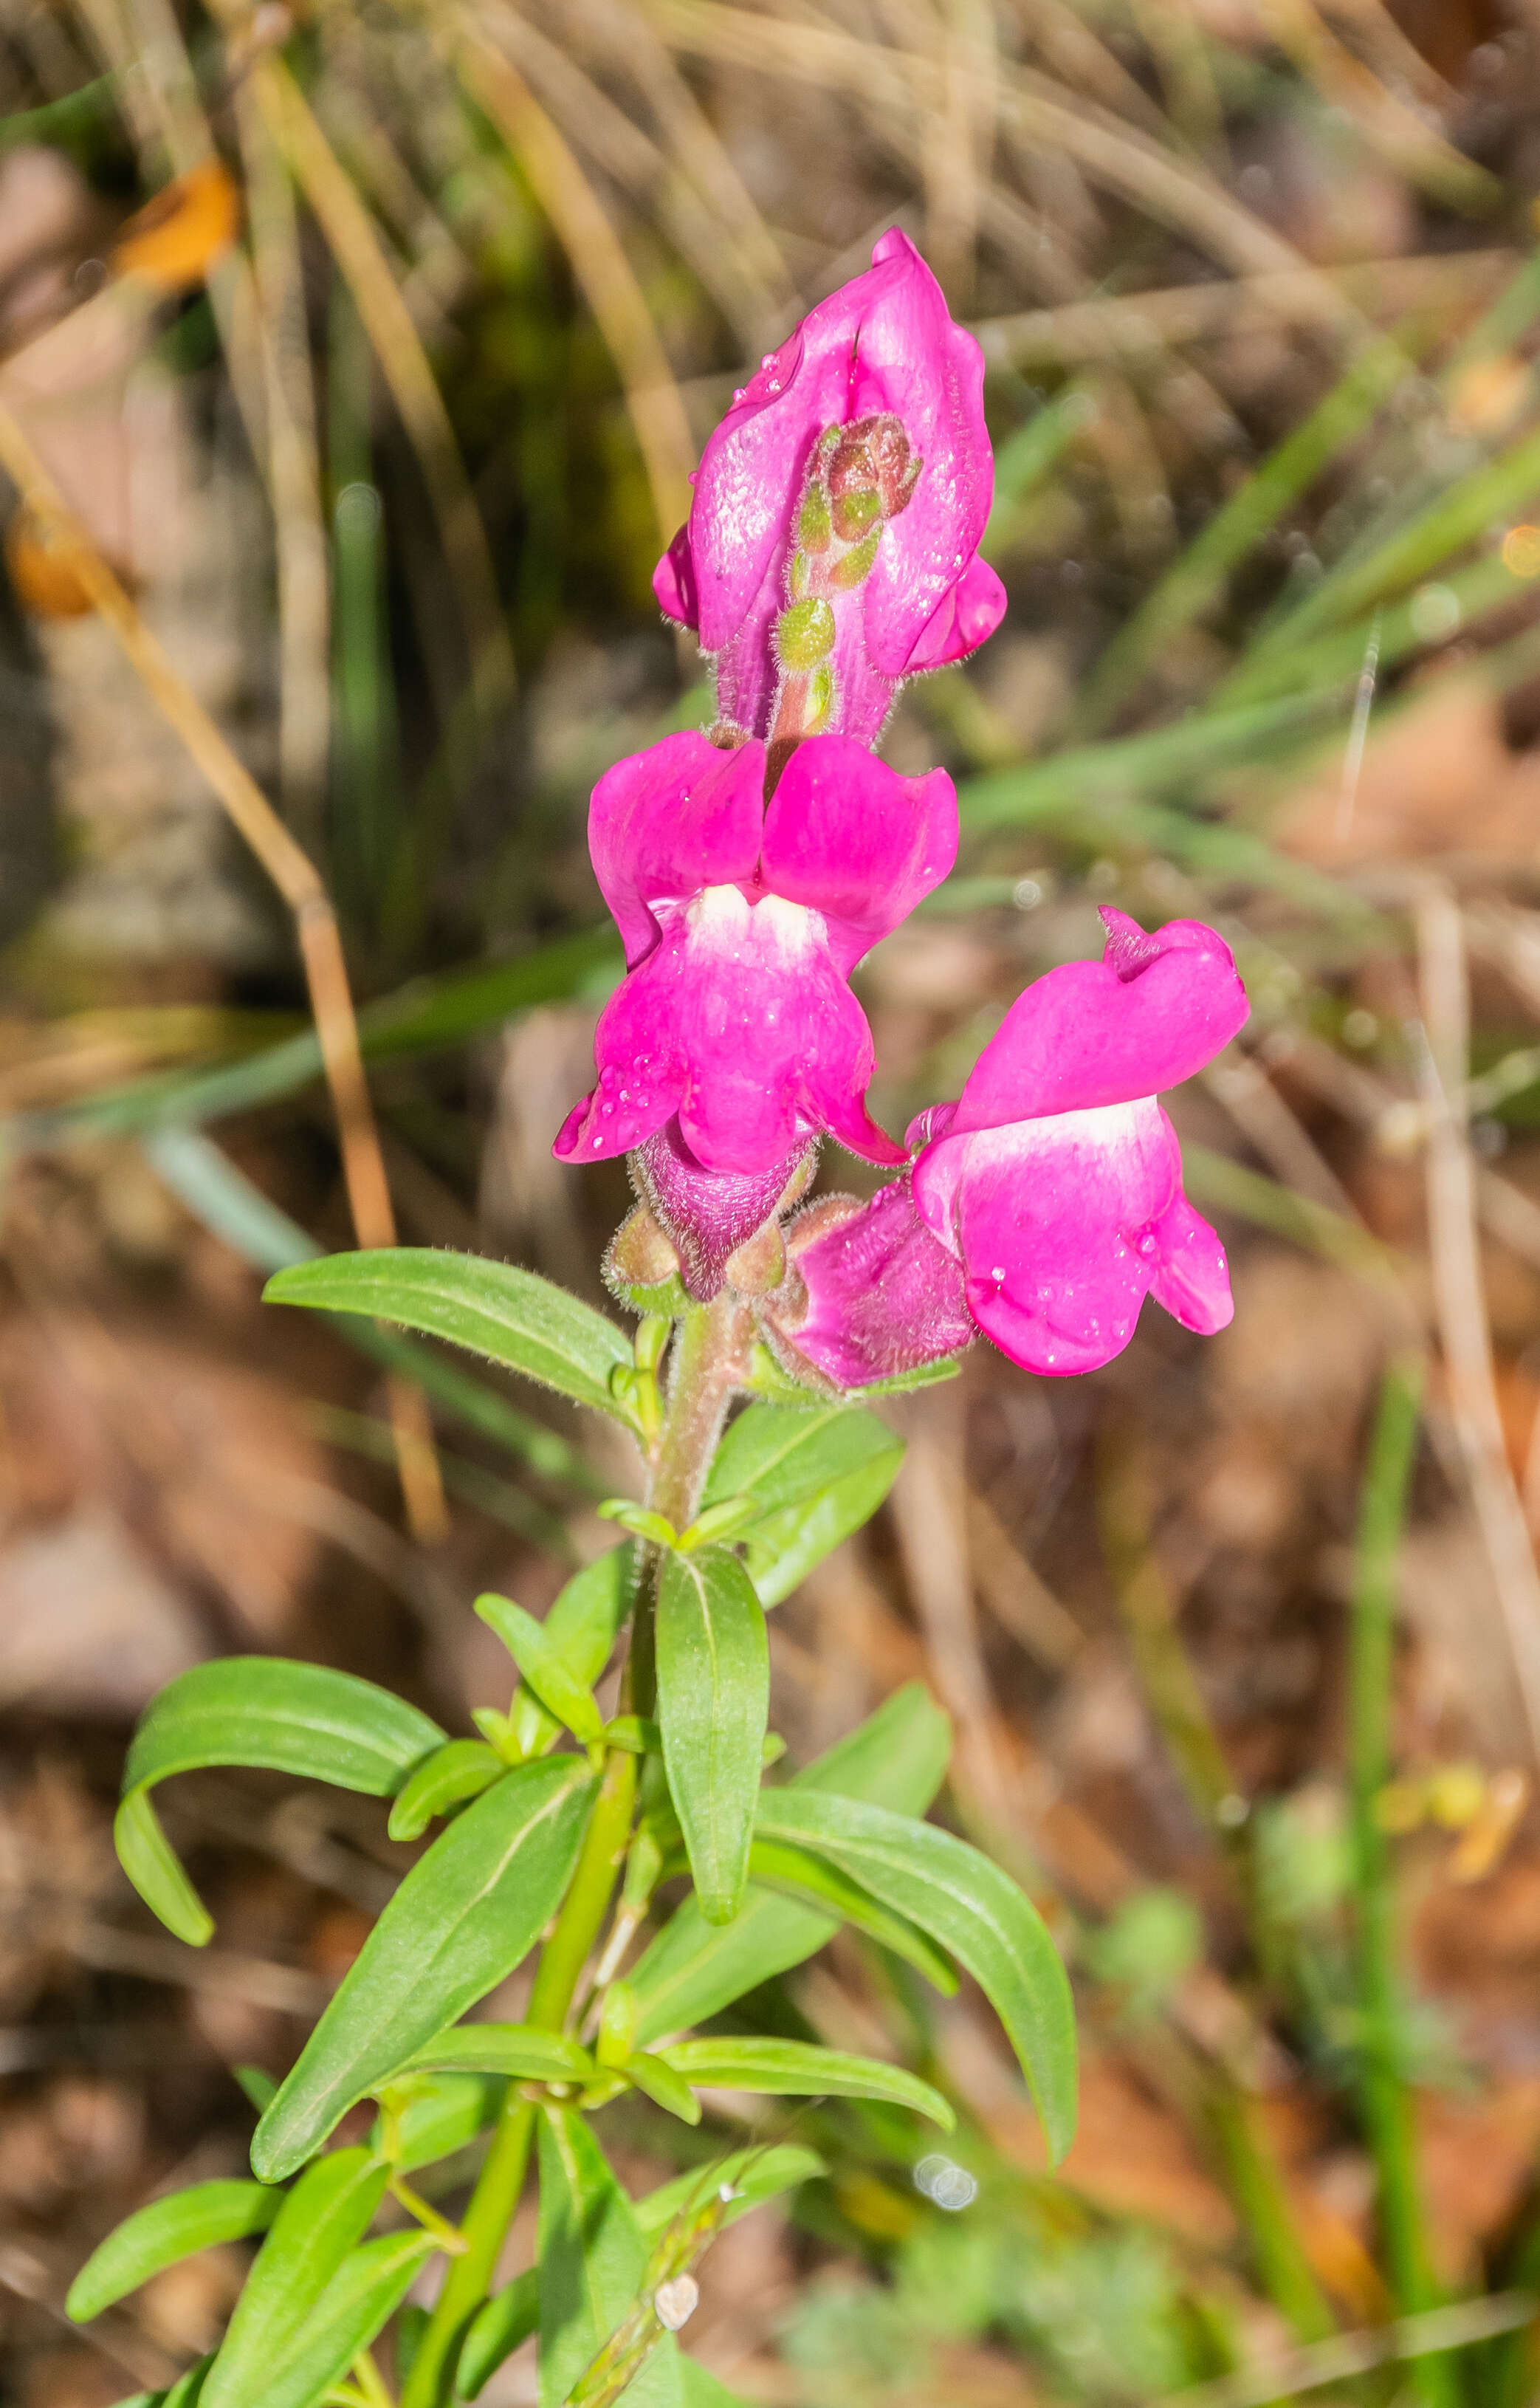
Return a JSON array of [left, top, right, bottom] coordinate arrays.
[[556, 732, 958, 1184]]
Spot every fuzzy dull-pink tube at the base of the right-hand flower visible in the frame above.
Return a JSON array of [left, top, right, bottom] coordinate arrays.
[[787, 1180, 972, 1387]]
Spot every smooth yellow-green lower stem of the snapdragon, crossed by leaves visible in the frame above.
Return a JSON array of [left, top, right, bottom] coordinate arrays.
[[402, 1748, 635, 2408]]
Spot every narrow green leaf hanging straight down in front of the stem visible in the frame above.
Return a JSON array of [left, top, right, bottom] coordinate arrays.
[[657, 1546, 770, 1924]]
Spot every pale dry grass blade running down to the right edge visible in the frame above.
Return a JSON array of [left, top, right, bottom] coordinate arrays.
[[1415, 879, 1540, 1755]]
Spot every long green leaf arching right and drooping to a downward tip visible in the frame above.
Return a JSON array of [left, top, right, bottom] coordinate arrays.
[[760, 1789, 1076, 2160]]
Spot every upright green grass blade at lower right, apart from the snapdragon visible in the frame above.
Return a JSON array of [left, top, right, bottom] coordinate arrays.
[[1347, 1360, 1458, 2408]]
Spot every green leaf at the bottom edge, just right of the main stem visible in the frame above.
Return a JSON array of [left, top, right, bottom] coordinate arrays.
[[539, 2107, 681, 2408]]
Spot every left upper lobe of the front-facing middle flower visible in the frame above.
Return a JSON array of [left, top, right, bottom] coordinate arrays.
[[587, 730, 765, 968]]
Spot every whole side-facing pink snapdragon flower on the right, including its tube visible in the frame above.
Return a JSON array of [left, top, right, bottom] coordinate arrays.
[[780, 910, 1249, 1387]]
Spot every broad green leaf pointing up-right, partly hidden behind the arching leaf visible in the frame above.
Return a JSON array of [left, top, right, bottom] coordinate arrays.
[[628, 1681, 950, 2045]]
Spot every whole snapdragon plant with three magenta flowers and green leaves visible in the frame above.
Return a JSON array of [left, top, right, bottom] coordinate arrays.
[[70, 233, 1246, 2408]]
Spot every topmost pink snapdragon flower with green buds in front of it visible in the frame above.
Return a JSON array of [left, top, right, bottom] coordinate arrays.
[[652, 229, 1006, 744]]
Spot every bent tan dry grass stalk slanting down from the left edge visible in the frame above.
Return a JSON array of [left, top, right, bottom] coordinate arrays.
[[0, 385, 445, 1539]]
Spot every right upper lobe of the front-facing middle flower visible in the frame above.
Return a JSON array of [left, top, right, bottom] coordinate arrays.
[[760, 737, 958, 973]]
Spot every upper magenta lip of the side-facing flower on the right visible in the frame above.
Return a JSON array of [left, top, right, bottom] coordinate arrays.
[[955, 915, 1249, 1129]]
